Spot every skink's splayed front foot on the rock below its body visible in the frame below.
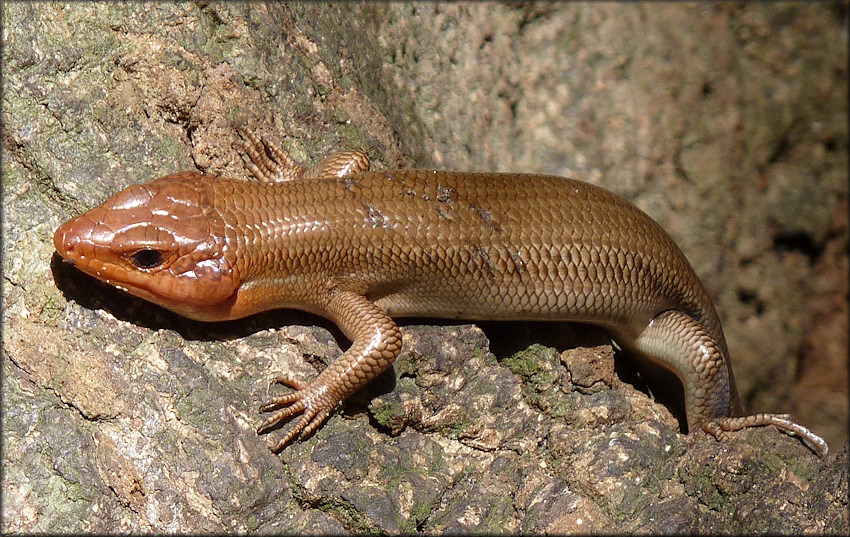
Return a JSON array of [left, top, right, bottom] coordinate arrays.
[[257, 376, 340, 453]]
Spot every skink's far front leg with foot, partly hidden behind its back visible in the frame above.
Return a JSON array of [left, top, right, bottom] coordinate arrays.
[[236, 127, 371, 183]]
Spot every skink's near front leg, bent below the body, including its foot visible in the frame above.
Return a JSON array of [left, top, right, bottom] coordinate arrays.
[[257, 289, 401, 452]]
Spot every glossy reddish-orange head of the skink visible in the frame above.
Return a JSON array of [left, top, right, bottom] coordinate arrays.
[[53, 172, 240, 321]]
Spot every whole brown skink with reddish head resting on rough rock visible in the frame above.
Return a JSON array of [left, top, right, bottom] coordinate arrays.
[[49, 129, 827, 456]]
